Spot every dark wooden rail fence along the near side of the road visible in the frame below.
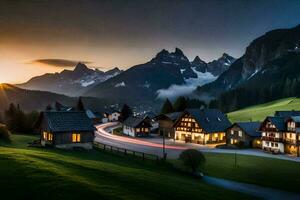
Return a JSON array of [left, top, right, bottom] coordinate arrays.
[[94, 142, 159, 162]]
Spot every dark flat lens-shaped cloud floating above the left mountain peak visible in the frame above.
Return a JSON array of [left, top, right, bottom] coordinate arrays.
[[30, 58, 92, 67]]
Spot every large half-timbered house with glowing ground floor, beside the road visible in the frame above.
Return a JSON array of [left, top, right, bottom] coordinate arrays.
[[174, 109, 231, 145]]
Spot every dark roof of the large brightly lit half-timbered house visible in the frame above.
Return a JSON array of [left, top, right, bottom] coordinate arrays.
[[184, 109, 231, 133]]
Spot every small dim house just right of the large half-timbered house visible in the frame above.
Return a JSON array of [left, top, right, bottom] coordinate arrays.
[[226, 122, 261, 148]]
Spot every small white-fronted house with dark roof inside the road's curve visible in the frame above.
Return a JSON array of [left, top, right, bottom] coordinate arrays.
[[123, 116, 151, 137]]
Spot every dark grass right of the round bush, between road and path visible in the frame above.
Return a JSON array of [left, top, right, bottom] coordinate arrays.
[[174, 153, 300, 193]]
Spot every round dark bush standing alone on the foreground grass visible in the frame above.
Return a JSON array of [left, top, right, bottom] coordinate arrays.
[[179, 149, 205, 174]]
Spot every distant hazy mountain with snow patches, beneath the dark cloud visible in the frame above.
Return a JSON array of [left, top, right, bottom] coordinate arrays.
[[17, 63, 122, 96]]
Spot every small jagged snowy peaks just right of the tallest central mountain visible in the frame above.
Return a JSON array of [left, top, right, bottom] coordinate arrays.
[[191, 53, 236, 76]]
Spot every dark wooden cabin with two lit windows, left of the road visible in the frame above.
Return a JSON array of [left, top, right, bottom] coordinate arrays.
[[36, 111, 95, 149]]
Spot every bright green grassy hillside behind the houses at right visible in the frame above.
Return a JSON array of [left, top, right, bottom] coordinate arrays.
[[228, 97, 300, 122]]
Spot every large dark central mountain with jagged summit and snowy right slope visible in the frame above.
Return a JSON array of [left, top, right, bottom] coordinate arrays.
[[84, 48, 236, 104]]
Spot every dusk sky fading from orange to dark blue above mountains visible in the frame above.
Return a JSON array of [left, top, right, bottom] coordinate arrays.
[[0, 0, 300, 83]]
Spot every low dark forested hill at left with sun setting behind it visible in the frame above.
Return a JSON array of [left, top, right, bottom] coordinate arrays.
[[0, 84, 107, 112]]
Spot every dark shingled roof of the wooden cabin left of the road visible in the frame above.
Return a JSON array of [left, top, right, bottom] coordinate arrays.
[[42, 111, 95, 132]]
